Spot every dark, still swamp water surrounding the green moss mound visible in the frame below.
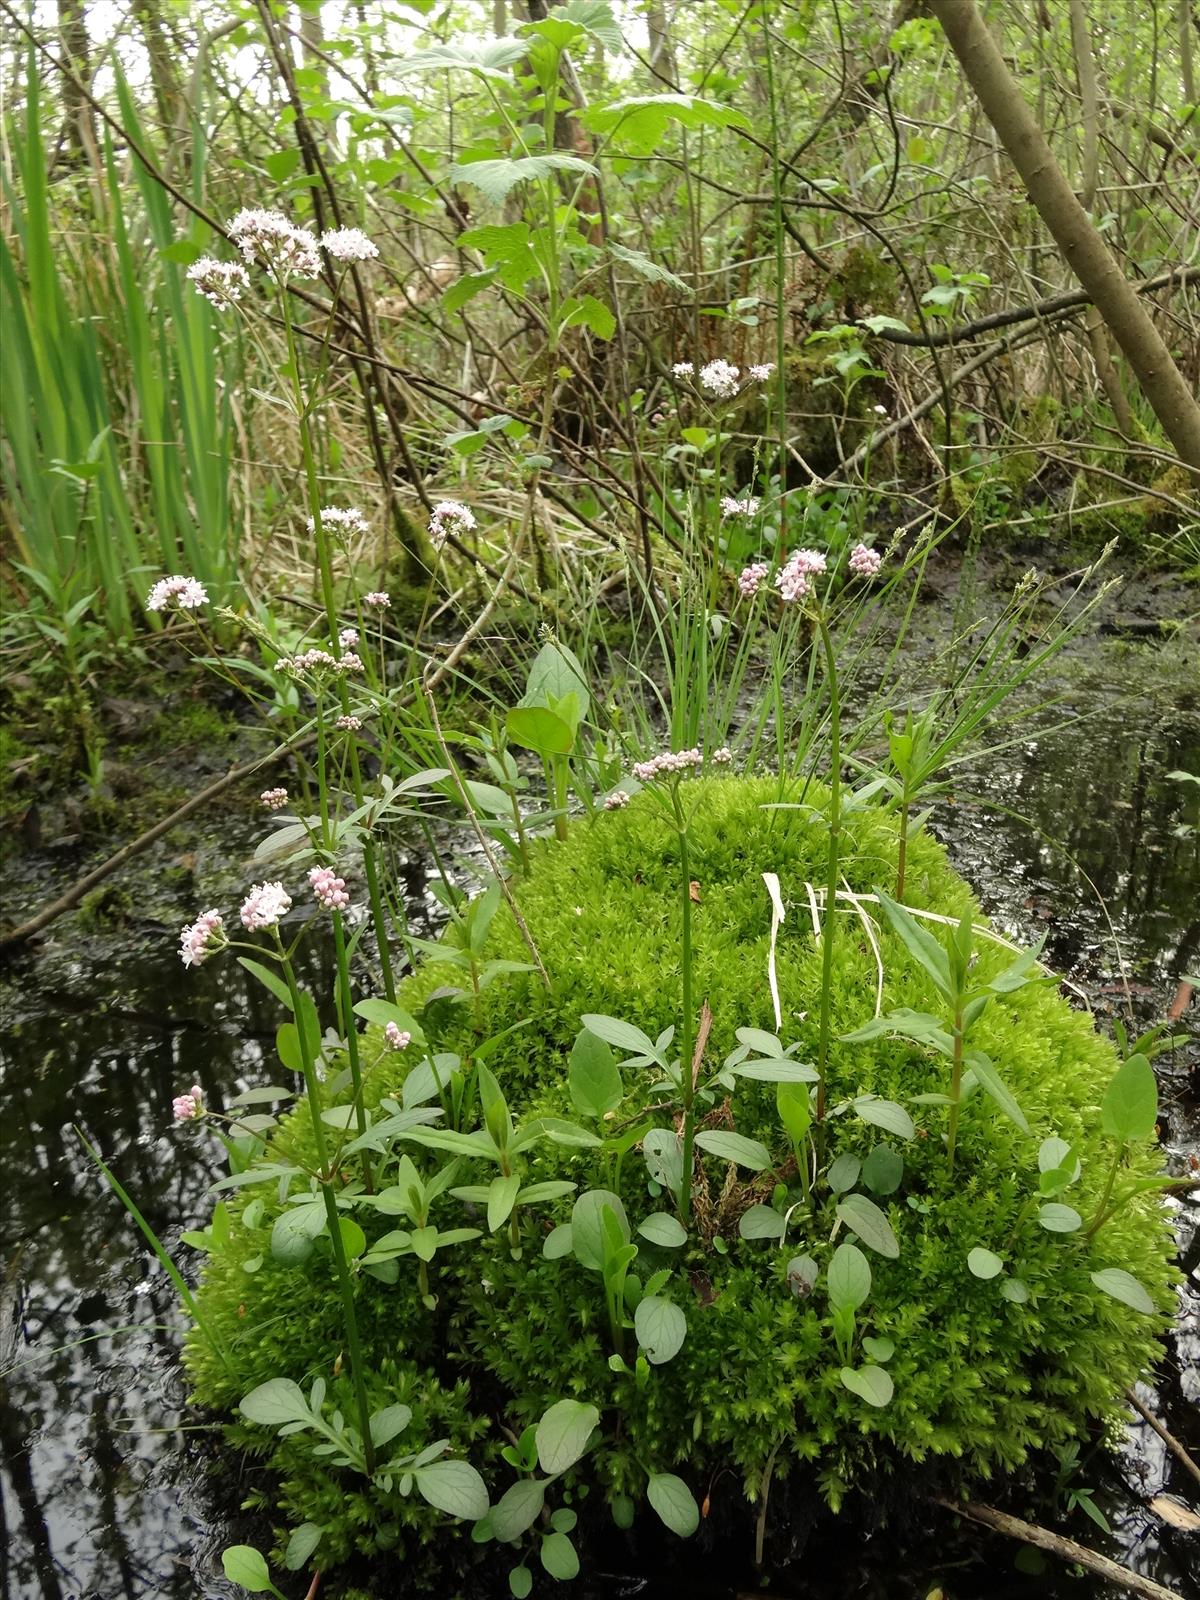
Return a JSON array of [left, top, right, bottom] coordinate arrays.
[[0, 582, 1200, 1600]]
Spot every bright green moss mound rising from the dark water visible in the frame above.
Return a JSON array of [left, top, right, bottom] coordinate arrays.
[[187, 778, 1173, 1566]]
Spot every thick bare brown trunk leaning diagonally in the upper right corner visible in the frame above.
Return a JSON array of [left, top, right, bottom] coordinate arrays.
[[930, 0, 1200, 477]]
